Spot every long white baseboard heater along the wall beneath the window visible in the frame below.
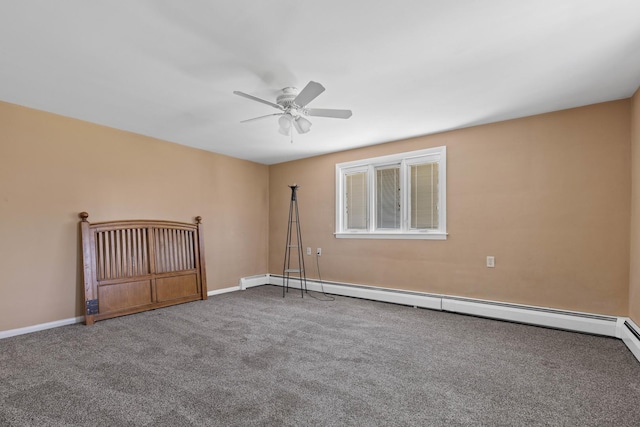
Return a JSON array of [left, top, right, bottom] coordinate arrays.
[[270, 275, 619, 337]]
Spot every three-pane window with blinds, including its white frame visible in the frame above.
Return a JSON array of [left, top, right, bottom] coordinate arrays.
[[335, 147, 447, 240]]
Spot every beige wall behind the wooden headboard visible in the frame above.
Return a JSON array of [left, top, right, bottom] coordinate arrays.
[[0, 102, 269, 331]]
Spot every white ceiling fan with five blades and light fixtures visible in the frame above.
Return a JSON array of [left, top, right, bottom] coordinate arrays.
[[233, 81, 351, 139]]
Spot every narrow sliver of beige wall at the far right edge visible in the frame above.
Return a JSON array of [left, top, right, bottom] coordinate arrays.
[[629, 89, 640, 324]]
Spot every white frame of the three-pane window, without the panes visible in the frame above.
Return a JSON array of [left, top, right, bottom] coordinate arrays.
[[334, 146, 447, 240]]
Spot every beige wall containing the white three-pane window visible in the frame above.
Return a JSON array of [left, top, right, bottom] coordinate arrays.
[[269, 100, 637, 315]]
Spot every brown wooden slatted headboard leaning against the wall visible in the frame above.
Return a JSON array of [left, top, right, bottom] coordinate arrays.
[[79, 212, 207, 325]]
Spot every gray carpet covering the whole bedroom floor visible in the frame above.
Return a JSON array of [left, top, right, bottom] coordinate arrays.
[[0, 286, 640, 426]]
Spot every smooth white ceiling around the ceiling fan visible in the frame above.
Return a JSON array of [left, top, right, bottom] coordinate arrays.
[[0, 0, 640, 164]]
